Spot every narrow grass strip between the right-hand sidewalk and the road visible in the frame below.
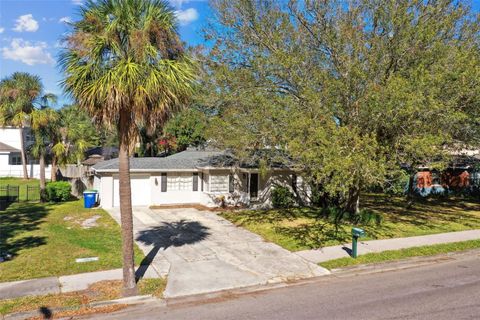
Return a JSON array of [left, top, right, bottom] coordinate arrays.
[[319, 240, 480, 269]]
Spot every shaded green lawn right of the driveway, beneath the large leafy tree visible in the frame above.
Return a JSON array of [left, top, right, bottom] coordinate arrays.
[[222, 194, 480, 251]]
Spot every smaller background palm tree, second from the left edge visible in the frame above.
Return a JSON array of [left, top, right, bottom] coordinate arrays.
[[31, 106, 59, 201]]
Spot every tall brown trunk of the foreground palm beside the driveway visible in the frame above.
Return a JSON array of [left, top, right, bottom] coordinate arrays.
[[118, 113, 137, 296]]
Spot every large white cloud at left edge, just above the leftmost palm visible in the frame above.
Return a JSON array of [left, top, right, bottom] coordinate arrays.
[[2, 38, 55, 66]]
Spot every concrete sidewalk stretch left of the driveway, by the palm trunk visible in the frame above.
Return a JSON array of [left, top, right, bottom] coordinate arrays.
[[0, 268, 159, 300]]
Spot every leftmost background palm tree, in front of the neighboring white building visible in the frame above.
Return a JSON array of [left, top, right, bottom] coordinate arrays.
[[0, 72, 54, 179]]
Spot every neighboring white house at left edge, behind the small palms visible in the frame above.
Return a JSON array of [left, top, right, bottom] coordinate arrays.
[[0, 127, 51, 178]]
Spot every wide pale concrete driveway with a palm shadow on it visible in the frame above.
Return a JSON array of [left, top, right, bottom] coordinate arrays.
[[109, 207, 328, 298]]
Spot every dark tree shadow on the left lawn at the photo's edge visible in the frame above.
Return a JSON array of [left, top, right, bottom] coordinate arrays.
[[0, 203, 49, 259]]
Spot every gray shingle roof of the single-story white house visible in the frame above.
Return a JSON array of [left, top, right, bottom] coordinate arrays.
[[93, 150, 231, 172]]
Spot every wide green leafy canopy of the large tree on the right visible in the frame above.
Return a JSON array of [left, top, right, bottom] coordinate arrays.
[[202, 0, 480, 215]]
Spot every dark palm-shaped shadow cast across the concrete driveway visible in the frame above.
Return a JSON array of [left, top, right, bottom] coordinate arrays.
[[135, 219, 210, 281]]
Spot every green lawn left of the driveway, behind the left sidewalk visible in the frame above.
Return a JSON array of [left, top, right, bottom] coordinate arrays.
[[0, 200, 143, 282]]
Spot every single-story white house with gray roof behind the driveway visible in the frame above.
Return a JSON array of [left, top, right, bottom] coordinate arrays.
[[93, 149, 308, 208]]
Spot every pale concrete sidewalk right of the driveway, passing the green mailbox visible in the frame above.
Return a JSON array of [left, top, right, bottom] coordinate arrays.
[[296, 230, 480, 263]]
